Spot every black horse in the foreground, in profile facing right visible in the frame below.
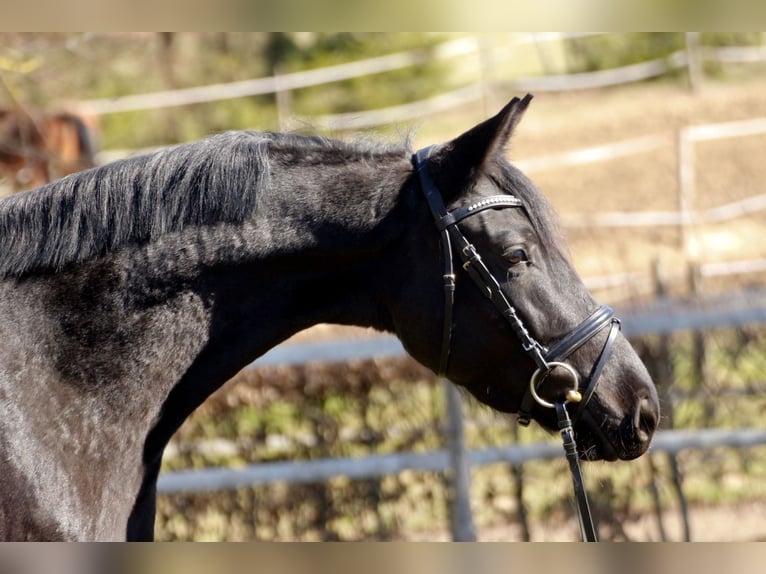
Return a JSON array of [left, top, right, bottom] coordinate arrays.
[[0, 97, 658, 540]]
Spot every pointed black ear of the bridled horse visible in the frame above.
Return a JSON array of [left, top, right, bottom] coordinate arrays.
[[431, 94, 532, 200]]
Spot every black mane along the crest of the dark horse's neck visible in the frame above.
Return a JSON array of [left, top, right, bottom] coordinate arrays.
[[0, 132, 407, 277]]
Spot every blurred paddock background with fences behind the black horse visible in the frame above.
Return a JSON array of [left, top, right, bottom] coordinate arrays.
[[0, 32, 766, 541]]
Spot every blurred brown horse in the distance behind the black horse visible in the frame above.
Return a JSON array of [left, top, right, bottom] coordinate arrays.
[[0, 107, 95, 196]]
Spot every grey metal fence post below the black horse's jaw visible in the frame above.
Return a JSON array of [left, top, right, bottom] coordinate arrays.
[[443, 379, 476, 542]]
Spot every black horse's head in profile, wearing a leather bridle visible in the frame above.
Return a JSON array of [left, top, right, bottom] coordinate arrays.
[[397, 96, 659, 460]]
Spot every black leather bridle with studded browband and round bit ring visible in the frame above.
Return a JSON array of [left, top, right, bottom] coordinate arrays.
[[412, 146, 620, 541]]
